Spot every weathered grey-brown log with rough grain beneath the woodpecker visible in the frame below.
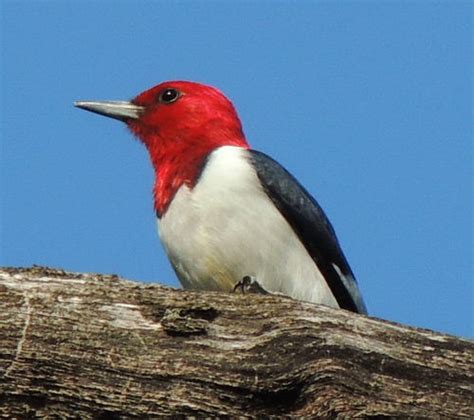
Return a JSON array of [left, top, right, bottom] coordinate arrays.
[[0, 266, 474, 419]]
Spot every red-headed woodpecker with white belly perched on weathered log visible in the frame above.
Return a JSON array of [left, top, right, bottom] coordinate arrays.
[[74, 80, 367, 314]]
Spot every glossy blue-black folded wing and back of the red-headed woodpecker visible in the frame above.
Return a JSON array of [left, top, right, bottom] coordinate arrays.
[[249, 150, 367, 314]]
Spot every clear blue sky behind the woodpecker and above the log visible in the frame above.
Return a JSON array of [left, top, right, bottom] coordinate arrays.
[[0, 0, 474, 337]]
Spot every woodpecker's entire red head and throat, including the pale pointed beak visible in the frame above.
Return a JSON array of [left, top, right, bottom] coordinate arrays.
[[76, 81, 249, 215]]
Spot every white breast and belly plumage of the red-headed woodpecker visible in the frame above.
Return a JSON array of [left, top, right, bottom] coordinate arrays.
[[158, 146, 338, 307]]
